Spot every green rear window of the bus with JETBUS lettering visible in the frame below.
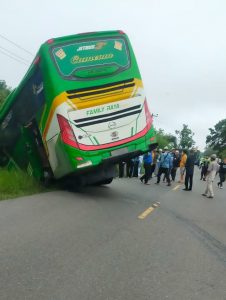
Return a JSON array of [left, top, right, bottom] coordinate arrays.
[[52, 38, 130, 79]]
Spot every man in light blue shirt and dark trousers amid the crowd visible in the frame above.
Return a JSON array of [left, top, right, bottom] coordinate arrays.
[[156, 147, 172, 186]]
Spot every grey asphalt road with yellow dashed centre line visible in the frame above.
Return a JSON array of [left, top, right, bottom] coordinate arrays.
[[0, 170, 226, 300]]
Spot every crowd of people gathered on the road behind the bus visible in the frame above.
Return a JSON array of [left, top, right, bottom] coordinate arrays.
[[119, 147, 226, 198]]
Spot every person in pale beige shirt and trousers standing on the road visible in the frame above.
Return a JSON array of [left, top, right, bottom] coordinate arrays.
[[202, 154, 220, 198]]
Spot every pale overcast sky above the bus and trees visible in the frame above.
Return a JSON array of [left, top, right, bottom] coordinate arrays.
[[0, 0, 226, 150]]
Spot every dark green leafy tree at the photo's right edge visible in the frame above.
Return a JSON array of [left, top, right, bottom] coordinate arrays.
[[206, 119, 226, 154]]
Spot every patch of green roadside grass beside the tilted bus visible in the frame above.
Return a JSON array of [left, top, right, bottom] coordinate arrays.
[[0, 169, 44, 200]]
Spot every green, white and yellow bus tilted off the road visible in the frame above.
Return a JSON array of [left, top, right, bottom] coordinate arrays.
[[0, 31, 157, 184]]
